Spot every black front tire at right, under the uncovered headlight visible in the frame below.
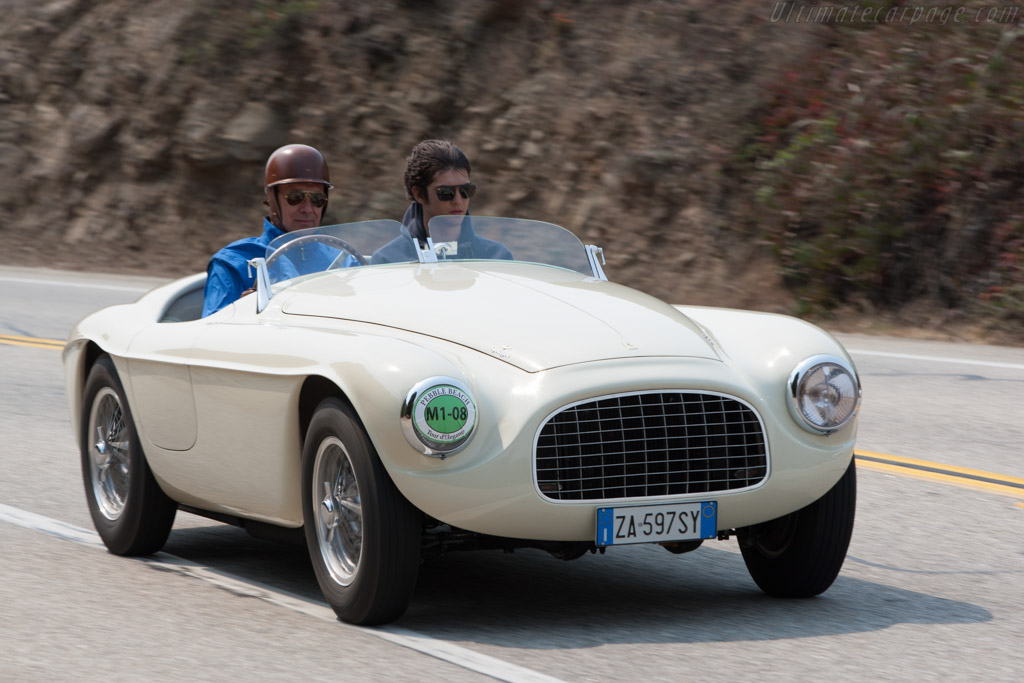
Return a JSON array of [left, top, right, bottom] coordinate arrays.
[[737, 461, 857, 598]]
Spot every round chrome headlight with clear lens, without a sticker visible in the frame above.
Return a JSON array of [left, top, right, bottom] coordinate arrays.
[[787, 355, 860, 434]]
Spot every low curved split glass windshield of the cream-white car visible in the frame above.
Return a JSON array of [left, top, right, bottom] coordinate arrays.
[[266, 216, 595, 285]]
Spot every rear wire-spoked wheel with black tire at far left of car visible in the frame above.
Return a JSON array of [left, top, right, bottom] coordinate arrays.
[[79, 355, 178, 555]]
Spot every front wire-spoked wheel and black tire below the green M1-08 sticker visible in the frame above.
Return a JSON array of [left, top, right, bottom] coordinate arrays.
[[302, 398, 423, 625]]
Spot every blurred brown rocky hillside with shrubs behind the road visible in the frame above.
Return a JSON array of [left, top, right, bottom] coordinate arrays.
[[0, 0, 1024, 336]]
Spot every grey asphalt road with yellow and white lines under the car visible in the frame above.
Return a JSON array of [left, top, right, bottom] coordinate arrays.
[[0, 268, 1024, 682]]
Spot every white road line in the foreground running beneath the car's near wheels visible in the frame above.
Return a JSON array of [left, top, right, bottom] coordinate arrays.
[[0, 503, 562, 683]]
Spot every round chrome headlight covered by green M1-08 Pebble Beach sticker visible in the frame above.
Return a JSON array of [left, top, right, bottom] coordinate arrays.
[[400, 377, 476, 459]]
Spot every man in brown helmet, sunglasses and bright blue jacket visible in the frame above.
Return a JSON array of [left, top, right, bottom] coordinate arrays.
[[203, 144, 334, 317]]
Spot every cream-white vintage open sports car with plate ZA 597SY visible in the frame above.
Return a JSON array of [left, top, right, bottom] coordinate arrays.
[[63, 216, 860, 624]]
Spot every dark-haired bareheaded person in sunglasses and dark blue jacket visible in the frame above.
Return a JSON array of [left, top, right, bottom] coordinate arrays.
[[370, 140, 512, 263]]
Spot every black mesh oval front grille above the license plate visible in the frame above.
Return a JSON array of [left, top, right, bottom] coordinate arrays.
[[535, 391, 768, 501]]
